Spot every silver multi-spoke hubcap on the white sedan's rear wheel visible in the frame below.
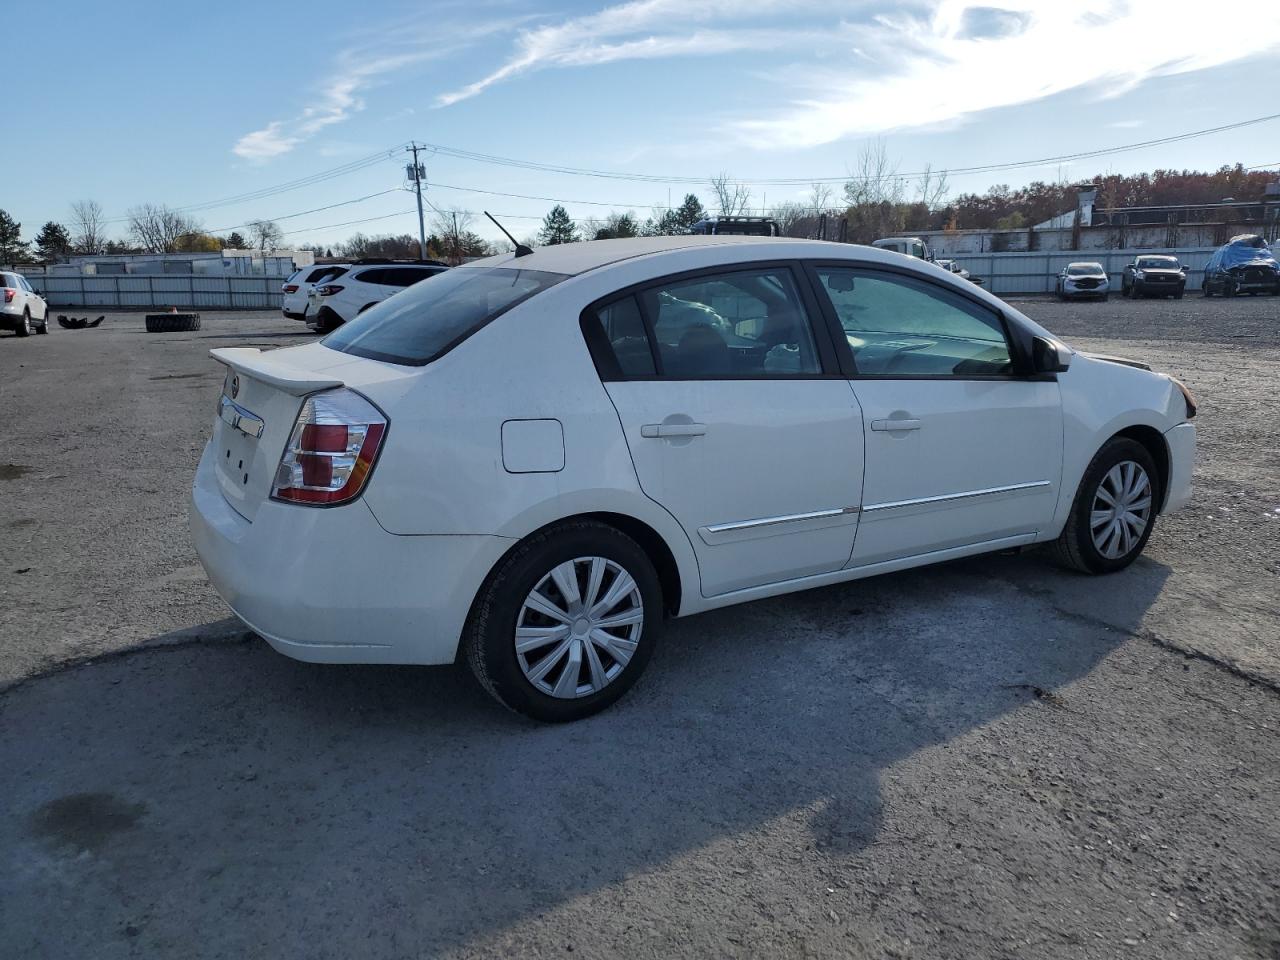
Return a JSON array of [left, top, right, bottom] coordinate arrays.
[[515, 557, 644, 700]]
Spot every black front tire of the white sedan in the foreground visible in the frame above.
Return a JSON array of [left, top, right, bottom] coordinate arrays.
[[1053, 436, 1164, 573]]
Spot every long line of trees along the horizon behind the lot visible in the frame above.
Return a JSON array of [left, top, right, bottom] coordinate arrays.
[[0, 156, 1275, 264]]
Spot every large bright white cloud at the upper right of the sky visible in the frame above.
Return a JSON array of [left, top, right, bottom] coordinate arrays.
[[728, 0, 1280, 147]]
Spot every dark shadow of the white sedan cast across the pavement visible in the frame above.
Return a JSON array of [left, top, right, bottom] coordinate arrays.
[[0, 557, 1169, 957]]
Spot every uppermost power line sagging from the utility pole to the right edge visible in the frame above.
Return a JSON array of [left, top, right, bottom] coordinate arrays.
[[426, 114, 1280, 186]]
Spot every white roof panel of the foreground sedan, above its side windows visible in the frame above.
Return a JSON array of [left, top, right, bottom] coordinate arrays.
[[465, 234, 926, 276]]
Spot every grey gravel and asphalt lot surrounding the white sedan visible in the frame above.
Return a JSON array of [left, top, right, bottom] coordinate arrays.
[[0, 297, 1280, 959]]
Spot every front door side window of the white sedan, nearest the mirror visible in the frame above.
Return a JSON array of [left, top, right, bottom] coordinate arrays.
[[817, 266, 1012, 378]]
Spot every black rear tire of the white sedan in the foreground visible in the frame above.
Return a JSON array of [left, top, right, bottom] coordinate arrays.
[[462, 520, 663, 723]]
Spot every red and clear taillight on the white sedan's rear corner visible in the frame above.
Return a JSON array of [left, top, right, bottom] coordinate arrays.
[[271, 388, 387, 506]]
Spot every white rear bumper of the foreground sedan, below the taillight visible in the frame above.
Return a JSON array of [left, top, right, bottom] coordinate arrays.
[[189, 447, 512, 663]]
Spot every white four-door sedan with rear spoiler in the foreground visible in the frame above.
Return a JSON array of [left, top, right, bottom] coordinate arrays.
[[191, 237, 1196, 721]]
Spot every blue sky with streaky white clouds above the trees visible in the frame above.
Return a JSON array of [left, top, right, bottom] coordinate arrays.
[[0, 0, 1280, 246]]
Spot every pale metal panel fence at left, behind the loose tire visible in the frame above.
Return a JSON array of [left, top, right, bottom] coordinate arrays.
[[29, 274, 284, 310]]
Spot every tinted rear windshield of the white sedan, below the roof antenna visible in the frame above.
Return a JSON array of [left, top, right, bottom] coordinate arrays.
[[321, 268, 564, 366]]
